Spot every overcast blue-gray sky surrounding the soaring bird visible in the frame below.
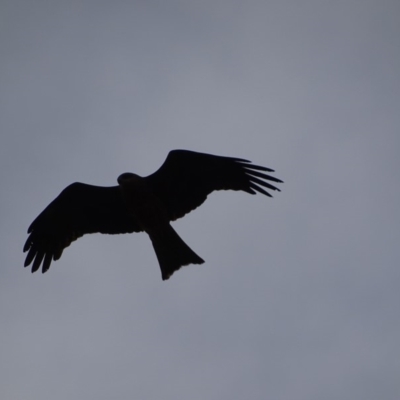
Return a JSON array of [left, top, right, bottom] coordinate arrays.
[[0, 0, 400, 400]]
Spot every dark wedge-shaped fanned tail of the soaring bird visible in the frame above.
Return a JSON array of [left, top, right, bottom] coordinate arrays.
[[149, 224, 204, 281]]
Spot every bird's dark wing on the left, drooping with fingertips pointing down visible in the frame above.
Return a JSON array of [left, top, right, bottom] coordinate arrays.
[[24, 182, 141, 273]]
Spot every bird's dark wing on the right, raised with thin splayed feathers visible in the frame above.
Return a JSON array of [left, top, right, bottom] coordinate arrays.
[[145, 150, 282, 220]]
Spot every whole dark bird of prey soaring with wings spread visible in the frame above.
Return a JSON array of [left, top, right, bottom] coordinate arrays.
[[24, 150, 282, 280]]
